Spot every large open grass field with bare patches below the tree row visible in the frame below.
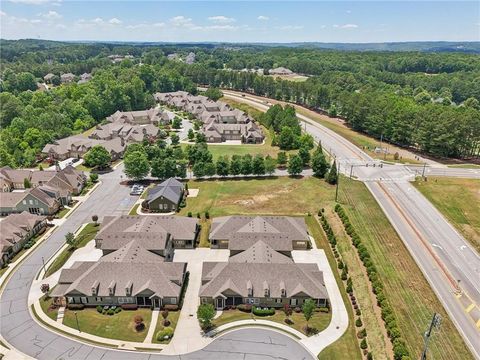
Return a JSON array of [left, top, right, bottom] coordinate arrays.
[[180, 176, 335, 216]]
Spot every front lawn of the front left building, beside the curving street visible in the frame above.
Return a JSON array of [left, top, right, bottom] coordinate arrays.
[[63, 308, 152, 342]]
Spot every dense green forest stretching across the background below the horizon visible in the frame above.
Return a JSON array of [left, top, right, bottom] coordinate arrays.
[[0, 40, 480, 167]]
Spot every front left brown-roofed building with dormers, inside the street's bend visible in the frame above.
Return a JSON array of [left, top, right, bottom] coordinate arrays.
[[51, 245, 187, 309]]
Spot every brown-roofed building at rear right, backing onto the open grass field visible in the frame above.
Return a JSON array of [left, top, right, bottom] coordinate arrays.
[[209, 216, 310, 256]]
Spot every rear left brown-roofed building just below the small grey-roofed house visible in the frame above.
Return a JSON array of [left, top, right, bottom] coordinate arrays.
[[95, 215, 200, 255]]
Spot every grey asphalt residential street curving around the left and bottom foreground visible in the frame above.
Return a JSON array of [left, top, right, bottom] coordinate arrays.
[[0, 166, 313, 360]]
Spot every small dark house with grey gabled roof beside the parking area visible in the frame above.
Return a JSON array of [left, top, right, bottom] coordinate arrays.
[[142, 178, 185, 212]]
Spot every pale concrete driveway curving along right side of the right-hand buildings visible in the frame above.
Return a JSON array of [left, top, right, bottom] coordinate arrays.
[[292, 248, 348, 354]]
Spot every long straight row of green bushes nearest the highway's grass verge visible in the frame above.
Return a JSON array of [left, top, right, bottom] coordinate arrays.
[[336, 204, 410, 360]]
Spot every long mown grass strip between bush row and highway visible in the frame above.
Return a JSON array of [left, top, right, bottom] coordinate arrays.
[[339, 177, 472, 360]]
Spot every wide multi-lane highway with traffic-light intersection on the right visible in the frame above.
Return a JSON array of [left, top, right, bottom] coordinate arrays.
[[223, 90, 480, 359]]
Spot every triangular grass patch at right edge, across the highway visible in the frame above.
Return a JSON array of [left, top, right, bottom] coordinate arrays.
[[414, 177, 480, 251]]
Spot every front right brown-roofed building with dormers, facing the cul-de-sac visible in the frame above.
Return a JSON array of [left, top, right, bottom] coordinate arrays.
[[199, 262, 328, 309]]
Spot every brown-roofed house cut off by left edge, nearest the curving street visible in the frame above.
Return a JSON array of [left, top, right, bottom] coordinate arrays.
[[0, 211, 47, 267]]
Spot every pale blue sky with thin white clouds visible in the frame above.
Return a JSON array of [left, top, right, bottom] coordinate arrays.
[[0, 0, 480, 43]]
